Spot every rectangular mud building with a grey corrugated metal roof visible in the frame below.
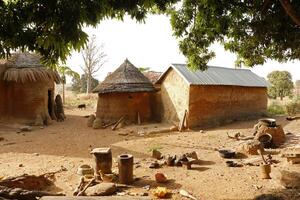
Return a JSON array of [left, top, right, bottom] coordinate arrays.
[[155, 64, 268, 127]]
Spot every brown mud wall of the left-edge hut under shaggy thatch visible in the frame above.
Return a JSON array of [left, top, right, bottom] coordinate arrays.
[[0, 82, 54, 123]]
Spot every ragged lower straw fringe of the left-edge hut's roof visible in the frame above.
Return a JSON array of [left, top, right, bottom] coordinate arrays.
[[3, 67, 61, 83]]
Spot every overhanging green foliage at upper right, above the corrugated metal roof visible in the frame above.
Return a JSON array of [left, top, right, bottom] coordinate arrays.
[[170, 0, 300, 69]]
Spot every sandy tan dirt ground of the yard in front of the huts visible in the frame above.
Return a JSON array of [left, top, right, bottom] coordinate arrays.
[[0, 109, 300, 200]]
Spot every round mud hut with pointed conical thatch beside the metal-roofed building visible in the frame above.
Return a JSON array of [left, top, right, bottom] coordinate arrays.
[[93, 59, 155, 123]]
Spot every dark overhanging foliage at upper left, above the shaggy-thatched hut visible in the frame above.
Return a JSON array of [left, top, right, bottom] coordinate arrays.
[[0, 0, 178, 66]]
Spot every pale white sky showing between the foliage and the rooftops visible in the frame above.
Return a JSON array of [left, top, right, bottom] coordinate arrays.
[[67, 15, 300, 81]]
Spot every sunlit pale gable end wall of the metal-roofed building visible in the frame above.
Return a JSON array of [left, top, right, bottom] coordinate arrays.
[[160, 69, 189, 123]]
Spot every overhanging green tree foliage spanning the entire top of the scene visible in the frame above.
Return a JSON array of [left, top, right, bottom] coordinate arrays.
[[0, 0, 300, 69]]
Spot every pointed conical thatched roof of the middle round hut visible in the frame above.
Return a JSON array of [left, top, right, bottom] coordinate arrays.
[[93, 59, 155, 94]]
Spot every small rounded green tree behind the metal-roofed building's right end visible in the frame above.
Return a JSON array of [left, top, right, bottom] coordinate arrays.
[[267, 71, 294, 100]]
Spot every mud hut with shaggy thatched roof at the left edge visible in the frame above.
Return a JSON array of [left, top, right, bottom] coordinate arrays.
[[0, 53, 60, 123]]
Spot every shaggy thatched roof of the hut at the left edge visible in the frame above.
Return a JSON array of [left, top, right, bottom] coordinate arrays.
[[0, 53, 60, 83]]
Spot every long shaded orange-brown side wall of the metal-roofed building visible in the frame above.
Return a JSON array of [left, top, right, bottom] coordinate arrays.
[[188, 85, 268, 127]]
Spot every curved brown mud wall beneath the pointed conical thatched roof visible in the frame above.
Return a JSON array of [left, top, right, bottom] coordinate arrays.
[[96, 92, 151, 123]]
